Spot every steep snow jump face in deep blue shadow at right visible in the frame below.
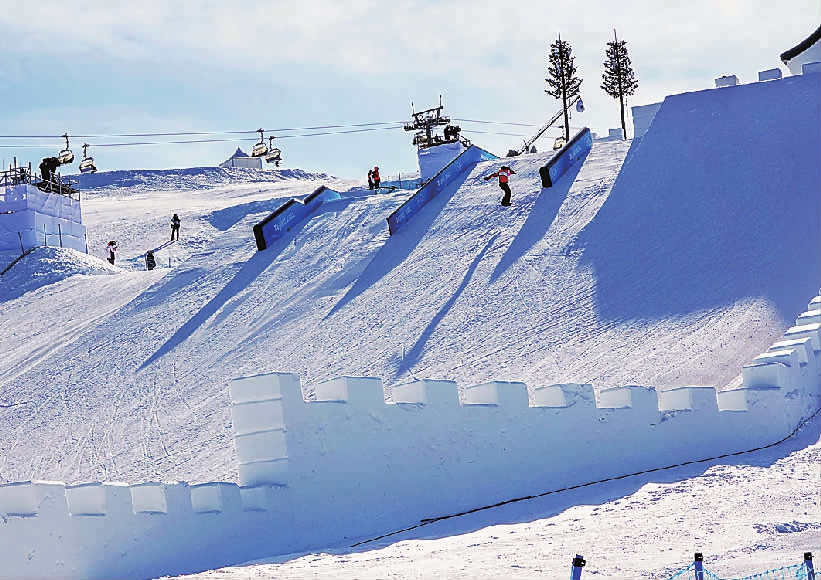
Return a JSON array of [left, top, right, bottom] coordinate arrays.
[[579, 75, 821, 321]]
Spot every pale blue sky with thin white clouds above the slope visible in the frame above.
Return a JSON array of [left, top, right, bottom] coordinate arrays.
[[0, 0, 821, 177]]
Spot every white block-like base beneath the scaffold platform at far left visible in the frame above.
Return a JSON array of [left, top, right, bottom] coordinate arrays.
[[0, 183, 86, 252]]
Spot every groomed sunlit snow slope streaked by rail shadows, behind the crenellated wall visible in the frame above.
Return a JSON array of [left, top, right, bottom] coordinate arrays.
[[0, 142, 800, 483]]
